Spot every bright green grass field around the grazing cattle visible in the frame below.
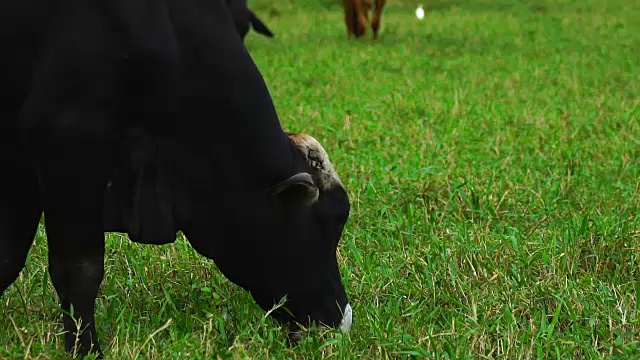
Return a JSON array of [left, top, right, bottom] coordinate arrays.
[[0, 0, 640, 359]]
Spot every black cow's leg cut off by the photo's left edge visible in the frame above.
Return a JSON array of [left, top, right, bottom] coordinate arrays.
[[0, 165, 42, 295]]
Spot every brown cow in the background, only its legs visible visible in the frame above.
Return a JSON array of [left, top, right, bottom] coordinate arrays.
[[342, 0, 387, 40]]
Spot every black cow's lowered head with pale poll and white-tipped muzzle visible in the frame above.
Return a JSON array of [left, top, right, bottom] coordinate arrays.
[[252, 134, 352, 332]]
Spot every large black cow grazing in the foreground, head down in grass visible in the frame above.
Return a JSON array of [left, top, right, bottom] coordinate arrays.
[[0, 0, 352, 354]]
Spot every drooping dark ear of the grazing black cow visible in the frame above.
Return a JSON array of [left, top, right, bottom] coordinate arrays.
[[271, 172, 320, 206]]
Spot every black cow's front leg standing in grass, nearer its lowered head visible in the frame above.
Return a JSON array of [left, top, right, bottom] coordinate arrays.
[[39, 138, 106, 356]]
